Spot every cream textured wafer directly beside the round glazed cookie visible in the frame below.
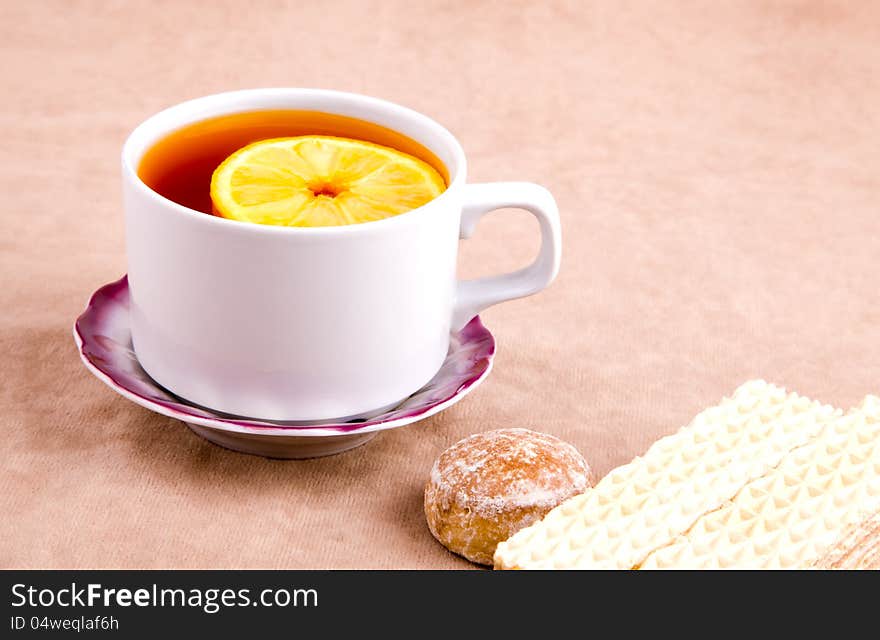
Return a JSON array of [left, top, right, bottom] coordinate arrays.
[[495, 380, 841, 569]]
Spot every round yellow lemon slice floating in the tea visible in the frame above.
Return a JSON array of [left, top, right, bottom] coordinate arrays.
[[211, 136, 446, 227]]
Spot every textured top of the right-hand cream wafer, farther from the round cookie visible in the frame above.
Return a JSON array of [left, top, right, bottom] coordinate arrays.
[[642, 396, 880, 569]]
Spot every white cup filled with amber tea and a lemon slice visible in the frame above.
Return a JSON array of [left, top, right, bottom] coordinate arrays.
[[122, 89, 561, 421]]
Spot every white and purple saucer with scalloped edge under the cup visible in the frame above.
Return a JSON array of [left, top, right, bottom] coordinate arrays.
[[73, 276, 495, 458]]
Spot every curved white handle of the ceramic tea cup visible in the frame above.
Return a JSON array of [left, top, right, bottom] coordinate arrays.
[[452, 182, 562, 331]]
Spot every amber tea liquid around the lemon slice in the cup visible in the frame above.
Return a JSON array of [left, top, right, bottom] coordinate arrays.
[[138, 109, 449, 215]]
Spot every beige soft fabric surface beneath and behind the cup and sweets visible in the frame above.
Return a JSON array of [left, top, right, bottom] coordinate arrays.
[[0, 0, 880, 568]]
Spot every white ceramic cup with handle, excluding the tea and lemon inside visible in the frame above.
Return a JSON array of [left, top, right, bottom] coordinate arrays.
[[122, 89, 561, 421]]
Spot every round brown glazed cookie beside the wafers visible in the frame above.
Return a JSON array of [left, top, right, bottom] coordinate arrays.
[[425, 429, 591, 564]]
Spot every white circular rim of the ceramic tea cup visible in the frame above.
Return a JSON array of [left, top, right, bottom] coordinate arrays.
[[122, 87, 467, 236]]
